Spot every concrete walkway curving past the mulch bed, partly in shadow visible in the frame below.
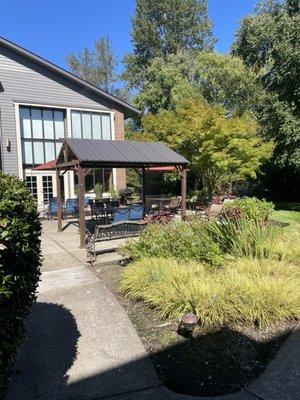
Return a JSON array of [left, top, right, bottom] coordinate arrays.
[[6, 222, 300, 400]]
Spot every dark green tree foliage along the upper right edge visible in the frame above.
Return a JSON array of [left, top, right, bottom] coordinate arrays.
[[233, 0, 300, 170]]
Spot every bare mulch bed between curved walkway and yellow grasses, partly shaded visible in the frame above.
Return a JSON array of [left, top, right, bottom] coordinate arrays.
[[94, 264, 294, 396]]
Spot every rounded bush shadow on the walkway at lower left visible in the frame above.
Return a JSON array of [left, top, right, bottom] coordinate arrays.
[[6, 303, 80, 400]]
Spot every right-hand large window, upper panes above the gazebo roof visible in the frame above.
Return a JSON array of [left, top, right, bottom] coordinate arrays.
[[71, 110, 112, 140]]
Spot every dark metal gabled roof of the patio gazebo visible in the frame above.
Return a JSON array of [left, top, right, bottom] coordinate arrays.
[[57, 138, 188, 168]]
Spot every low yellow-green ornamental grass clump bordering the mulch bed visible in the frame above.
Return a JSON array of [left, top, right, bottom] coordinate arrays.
[[121, 258, 300, 329]]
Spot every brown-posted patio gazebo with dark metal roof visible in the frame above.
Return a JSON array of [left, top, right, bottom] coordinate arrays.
[[55, 138, 188, 247]]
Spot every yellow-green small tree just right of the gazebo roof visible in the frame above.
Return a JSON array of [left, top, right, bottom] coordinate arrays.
[[141, 100, 273, 197]]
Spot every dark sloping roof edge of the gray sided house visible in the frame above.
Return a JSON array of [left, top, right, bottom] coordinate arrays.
[[0, 36, 141, 117]]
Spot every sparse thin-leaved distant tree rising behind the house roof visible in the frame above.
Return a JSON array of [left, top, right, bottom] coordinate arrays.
[[67, 36, 118, 93]]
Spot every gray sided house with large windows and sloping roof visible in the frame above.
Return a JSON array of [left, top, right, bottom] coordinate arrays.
[[0, 37, 139, 204]]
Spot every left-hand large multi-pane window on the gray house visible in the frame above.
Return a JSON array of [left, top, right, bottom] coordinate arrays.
[[20, 107, 66, 167]]
